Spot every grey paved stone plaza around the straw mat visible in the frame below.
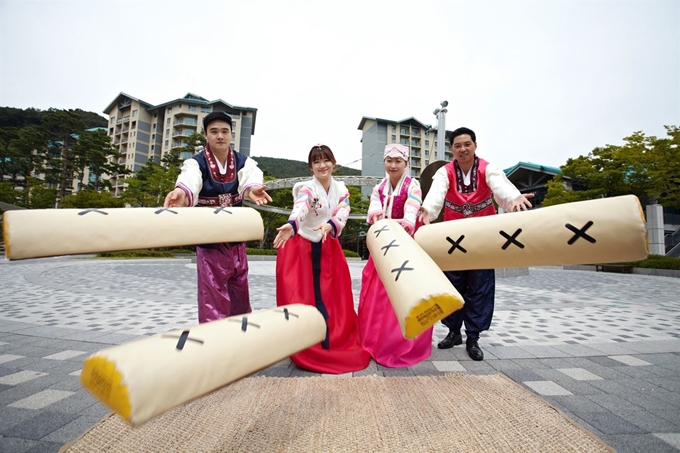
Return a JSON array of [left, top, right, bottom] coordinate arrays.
[[0, 257, 680, 453]]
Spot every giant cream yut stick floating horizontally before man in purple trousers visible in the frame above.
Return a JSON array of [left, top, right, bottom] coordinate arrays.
[[3, 207, 264, 260]]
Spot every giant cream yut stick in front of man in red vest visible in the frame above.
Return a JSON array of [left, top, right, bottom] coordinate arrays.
[[415, 195, 649, 271]]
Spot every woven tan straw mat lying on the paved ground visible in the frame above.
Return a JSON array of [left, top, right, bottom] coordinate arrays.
[[61, 374, 612, 453]]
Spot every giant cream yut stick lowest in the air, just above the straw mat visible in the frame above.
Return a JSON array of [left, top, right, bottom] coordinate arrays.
[[80, 304, 326, 425]]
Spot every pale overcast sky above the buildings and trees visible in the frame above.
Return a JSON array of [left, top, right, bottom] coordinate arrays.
[[0, 0, 680, 168]]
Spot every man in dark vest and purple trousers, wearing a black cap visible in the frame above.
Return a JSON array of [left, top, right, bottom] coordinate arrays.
[[163, 112, 271, 323]]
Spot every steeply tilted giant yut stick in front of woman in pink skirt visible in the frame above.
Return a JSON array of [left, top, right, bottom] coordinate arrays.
[[366, 219, 463, 338]]
